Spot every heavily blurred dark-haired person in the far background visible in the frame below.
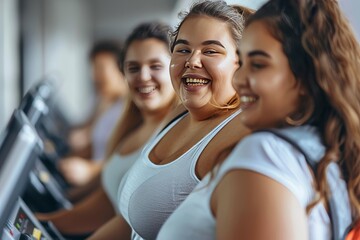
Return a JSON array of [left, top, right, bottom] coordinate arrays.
[[59, 40, 128, 186]]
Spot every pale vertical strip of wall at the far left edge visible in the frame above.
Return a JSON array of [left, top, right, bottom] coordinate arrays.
[[0, 0, 19, 131]]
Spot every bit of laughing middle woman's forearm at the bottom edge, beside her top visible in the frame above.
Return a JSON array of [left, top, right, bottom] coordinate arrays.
[[87, 215, 131, 240]]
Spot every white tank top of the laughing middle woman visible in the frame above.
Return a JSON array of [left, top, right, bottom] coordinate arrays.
[[118, 110, 241, 239]]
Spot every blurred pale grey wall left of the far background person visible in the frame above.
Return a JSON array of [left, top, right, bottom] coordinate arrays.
[[23, 0, 93, 122]]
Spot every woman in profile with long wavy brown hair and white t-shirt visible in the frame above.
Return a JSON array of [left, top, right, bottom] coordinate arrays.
[[158, 0, 360, 240]]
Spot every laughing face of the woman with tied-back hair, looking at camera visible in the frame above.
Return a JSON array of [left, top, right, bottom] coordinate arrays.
[[170, 16, 239, 116]]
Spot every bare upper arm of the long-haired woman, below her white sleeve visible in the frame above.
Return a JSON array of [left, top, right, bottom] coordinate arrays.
[[211, 170, 308, 240]]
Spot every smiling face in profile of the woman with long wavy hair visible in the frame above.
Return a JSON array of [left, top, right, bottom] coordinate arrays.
[[233, 21, 304, 130]]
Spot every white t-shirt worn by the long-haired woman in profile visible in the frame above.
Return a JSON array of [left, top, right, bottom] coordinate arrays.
[[157, 126, 351, 240]]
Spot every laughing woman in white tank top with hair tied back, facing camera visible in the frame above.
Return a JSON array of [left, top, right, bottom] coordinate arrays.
[[112, 1, 248, 239]]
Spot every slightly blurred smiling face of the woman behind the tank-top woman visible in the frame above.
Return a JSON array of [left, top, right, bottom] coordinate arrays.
[[124, 38, 174, 112]]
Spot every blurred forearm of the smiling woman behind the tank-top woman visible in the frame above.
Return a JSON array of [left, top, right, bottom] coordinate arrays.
[[37, 188, 115, 235]]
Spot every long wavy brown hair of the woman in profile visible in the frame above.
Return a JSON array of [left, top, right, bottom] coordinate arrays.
[[247, 0, 360, 220]]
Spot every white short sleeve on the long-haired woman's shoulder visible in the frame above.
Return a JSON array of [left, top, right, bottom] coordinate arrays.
[[219, 132, 313, 207]]
